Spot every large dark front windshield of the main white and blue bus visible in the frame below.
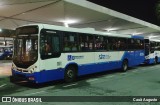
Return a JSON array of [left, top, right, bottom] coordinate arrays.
[[13, 27, 38, 68]]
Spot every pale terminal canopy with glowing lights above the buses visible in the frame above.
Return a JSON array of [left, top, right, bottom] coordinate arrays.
[[0, 0, 160, 39]]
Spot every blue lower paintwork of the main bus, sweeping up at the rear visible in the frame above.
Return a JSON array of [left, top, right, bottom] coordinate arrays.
[[12, 51, 144, 83]]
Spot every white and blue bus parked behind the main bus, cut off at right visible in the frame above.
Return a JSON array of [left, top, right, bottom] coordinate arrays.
[[145, 39, 160, 64]]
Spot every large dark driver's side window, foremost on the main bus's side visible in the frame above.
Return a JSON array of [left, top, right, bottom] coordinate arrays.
[[40, 30, 60, 59]]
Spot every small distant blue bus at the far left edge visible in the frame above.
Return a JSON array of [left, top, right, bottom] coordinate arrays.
[[0, 45, 13, 60]]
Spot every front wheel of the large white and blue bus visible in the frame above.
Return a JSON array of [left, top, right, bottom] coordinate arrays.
[[64, 66, 77, 82]]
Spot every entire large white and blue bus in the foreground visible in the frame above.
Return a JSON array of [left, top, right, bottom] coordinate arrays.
[[12, 24, 145, 83]]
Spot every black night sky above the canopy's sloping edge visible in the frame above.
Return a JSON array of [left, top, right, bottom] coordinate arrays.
[[88, 0, 160, 26]]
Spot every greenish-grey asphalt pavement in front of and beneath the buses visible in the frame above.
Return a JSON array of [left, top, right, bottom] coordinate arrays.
[[0, 62, 160, 105]]
